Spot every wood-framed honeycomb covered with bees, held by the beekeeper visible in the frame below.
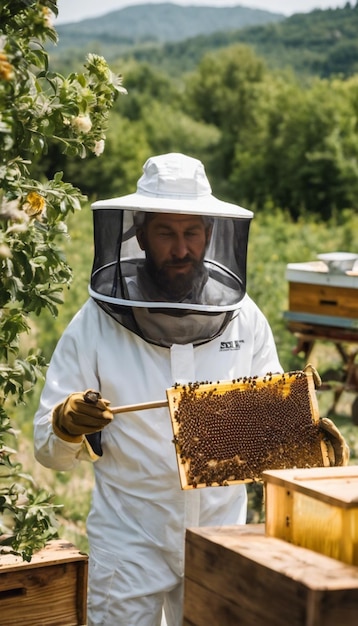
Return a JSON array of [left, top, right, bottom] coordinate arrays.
[[167, 368, 328, 488]]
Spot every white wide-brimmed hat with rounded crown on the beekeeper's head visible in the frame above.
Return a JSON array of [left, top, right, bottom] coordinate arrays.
[[92, 152, 253, 219]]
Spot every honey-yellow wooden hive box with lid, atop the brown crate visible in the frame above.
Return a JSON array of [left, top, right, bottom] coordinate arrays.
[[263, 465, 358, 566]]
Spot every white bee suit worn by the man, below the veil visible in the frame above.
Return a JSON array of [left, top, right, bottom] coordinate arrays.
[[34, 296, 282, 626]]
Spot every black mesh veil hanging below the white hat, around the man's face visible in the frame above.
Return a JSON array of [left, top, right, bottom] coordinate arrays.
[[90, 208, 251, 345]]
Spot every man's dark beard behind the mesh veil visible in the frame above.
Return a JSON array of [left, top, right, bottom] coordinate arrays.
[[146, 251, 206, 302]]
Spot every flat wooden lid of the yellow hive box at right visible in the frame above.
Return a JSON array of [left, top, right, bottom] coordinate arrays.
[[263, 465, 358, 509]]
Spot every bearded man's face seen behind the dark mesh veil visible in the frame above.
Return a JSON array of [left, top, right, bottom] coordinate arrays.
[[137, 213, 210, 298]]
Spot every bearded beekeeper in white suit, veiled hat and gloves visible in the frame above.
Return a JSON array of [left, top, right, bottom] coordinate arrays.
[[34, 153, 282, 626]]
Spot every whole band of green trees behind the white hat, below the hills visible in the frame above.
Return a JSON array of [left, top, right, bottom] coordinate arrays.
[[49, 39, 358, 220]]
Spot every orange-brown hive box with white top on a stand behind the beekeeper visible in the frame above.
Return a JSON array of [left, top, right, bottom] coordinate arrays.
[[284, 261, 358, 329]]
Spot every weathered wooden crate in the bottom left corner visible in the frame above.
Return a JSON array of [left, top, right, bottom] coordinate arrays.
[[0, 541, 88, 626]]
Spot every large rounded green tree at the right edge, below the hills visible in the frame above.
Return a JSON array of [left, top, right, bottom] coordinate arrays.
[[230, 71, 358, 220]]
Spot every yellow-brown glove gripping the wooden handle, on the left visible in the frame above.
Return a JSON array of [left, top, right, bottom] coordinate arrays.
[[52, 389, 113, 443]]
